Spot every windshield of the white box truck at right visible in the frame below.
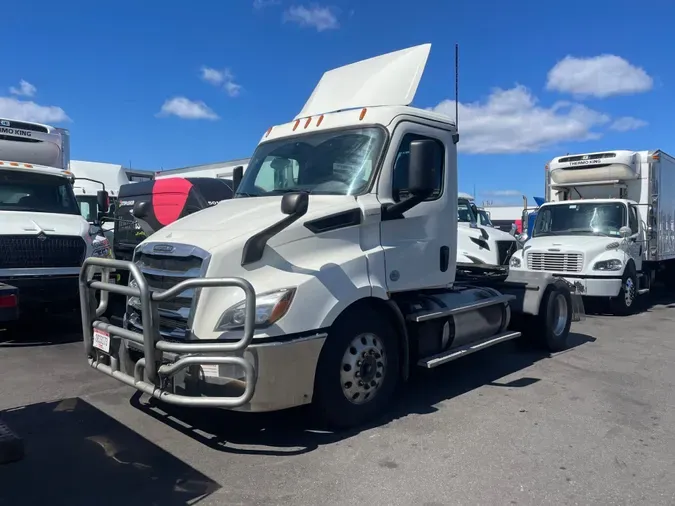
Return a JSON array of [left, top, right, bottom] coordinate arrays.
[[532, 202, 628, 237]]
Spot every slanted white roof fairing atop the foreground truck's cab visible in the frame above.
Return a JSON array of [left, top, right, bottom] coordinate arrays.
[[294, 44, 431, 119]]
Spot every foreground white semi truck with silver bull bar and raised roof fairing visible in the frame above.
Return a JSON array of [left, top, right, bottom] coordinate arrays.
[[80, 44, 580, 427]]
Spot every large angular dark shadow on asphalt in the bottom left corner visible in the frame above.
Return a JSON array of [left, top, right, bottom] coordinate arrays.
[[0, 398, 220, 506]]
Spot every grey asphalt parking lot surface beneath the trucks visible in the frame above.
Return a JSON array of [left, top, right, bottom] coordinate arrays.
[[0, 297, 675, 506]]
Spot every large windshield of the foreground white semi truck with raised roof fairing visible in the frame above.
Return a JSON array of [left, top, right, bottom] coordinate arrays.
[[237, 127, 386, 197]]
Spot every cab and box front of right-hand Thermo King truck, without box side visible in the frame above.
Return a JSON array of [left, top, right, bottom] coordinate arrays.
[[510, 151, 650, 314]]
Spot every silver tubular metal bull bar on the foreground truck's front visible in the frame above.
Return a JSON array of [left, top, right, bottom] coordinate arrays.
[[79, 257, 256, 408]]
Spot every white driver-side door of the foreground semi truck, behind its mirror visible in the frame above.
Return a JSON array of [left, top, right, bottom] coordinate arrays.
[[378, 121, 457, 292]]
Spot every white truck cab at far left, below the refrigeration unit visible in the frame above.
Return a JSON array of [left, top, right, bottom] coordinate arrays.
[[0, 160, 110, 313]]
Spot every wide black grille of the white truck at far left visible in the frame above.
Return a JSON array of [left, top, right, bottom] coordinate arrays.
[[0, 234, 87, 269]]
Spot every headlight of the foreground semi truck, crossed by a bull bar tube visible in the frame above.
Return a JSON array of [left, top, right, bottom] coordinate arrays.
[[214, 288, 295, 332]]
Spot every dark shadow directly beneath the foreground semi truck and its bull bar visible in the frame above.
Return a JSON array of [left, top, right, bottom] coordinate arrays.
[[130, 333, 595, 456]]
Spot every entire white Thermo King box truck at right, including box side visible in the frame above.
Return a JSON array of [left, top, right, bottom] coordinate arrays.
[[511, 150, 675, 314]]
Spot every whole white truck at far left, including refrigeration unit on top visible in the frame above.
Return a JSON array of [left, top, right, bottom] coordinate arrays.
[[0, 118, 110, 313]]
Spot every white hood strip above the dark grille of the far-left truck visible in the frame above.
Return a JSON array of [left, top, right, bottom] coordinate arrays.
[[0, 211, 89, 237]]
